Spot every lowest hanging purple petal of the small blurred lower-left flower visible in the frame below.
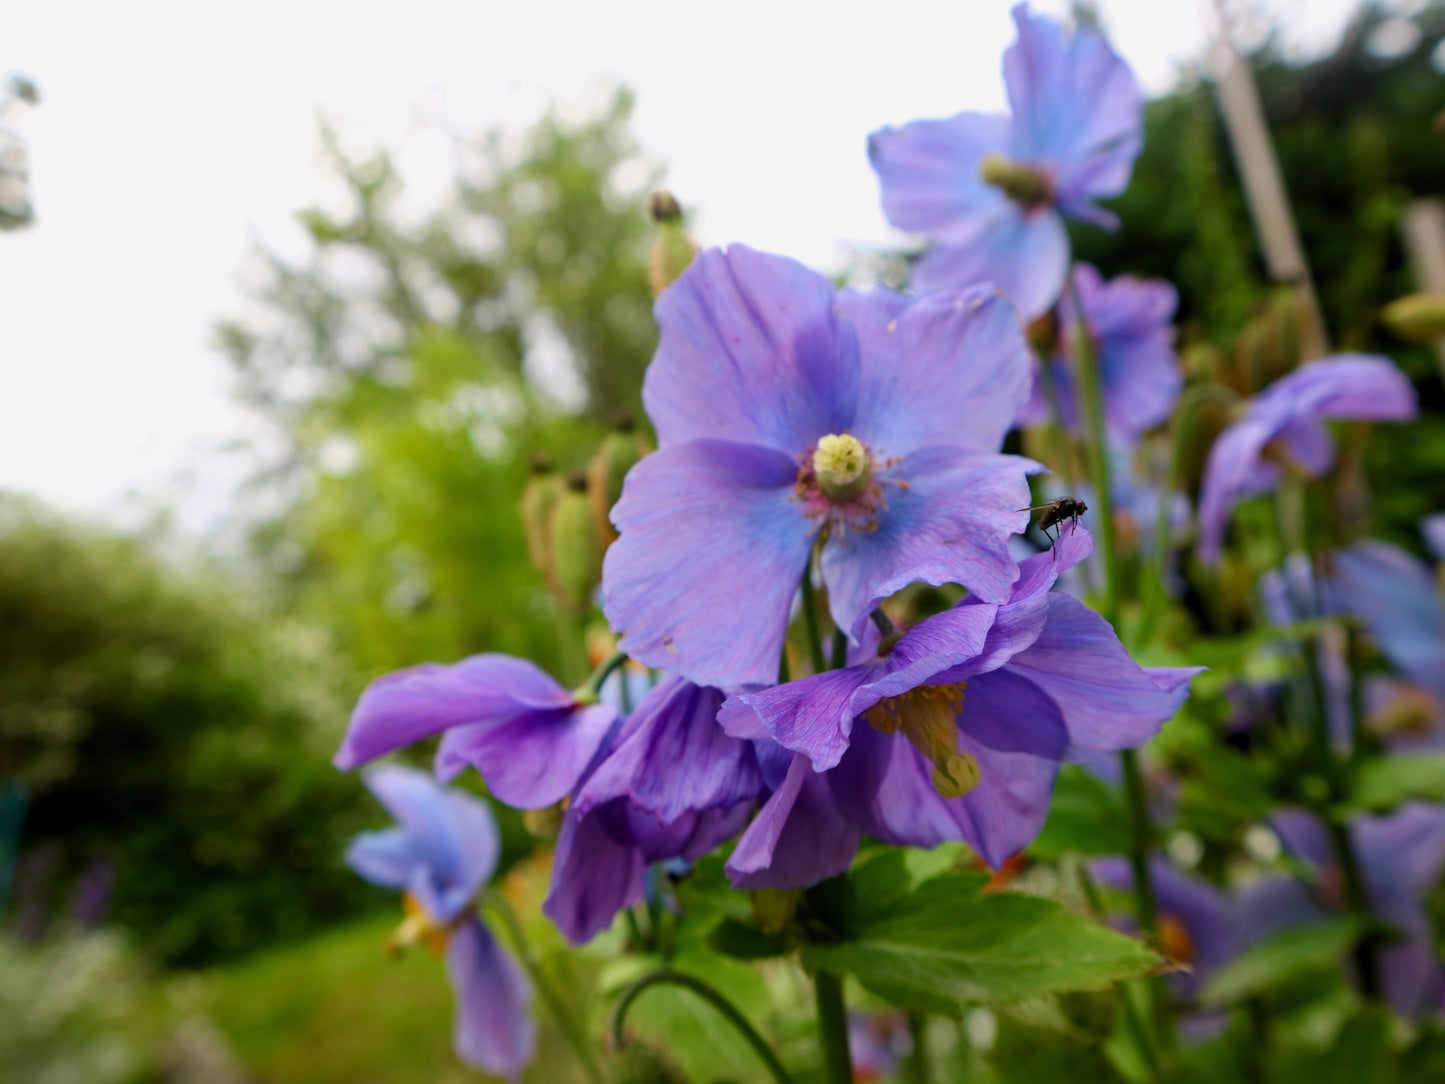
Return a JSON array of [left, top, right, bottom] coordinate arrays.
[[447, 918, 536, 1080]]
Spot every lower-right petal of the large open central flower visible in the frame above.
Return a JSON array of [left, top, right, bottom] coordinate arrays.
[[822, 448, 1043, 636]]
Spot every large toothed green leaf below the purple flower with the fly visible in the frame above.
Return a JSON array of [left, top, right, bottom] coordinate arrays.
[[803, 863, 1159, 1016]]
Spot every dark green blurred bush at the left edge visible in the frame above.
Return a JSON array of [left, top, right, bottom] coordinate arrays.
[[0, 497, 374, 963]]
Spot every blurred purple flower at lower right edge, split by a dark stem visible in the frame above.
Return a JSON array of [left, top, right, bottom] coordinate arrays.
[[1240, 802, 1445, 1016]]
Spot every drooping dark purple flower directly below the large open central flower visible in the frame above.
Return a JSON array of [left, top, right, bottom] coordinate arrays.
[[542, 676, 763, 942]]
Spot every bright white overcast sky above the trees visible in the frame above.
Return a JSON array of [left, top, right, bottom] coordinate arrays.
[[0, 0, 1375, 529]]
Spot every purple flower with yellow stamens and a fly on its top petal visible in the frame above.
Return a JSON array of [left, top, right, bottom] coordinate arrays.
[[718, 528, 1198, 887]]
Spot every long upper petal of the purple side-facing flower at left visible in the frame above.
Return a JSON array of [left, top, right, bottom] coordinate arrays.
[[332, 655, 572, 770]]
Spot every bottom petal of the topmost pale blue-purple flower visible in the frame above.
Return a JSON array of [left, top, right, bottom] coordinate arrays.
[[912, 201, 1069, 319]]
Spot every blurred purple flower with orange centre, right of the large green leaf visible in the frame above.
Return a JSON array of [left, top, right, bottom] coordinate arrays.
[[1090, 854, 1244, 999]]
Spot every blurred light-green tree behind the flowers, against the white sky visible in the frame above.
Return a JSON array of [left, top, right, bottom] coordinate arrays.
[[220, 91, 656, 675]]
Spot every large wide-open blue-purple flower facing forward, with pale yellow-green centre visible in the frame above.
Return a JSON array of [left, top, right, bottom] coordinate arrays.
[[603, 246, 1040, 688]]
